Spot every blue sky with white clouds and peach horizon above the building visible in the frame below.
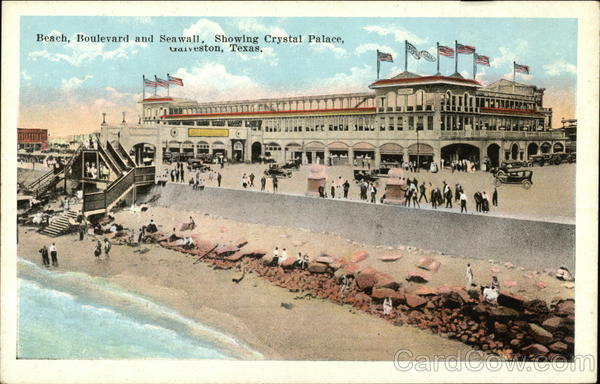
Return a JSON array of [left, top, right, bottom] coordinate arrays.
[[19, 16, 577, 139]]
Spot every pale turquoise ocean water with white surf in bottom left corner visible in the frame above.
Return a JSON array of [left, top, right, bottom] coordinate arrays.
[[17, 259, 262, 359]]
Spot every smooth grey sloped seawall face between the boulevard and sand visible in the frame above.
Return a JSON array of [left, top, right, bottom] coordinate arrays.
[[150, 184, 575, 270]]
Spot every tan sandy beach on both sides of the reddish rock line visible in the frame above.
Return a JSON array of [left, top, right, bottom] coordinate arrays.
[[18, 207, 573, 360]]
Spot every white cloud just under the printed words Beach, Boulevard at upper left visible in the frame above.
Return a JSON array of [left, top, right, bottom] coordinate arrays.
[[29, 31, 148, 67]]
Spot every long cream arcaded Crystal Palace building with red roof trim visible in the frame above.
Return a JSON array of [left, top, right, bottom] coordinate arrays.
[[101, 72, 566, 167]]
